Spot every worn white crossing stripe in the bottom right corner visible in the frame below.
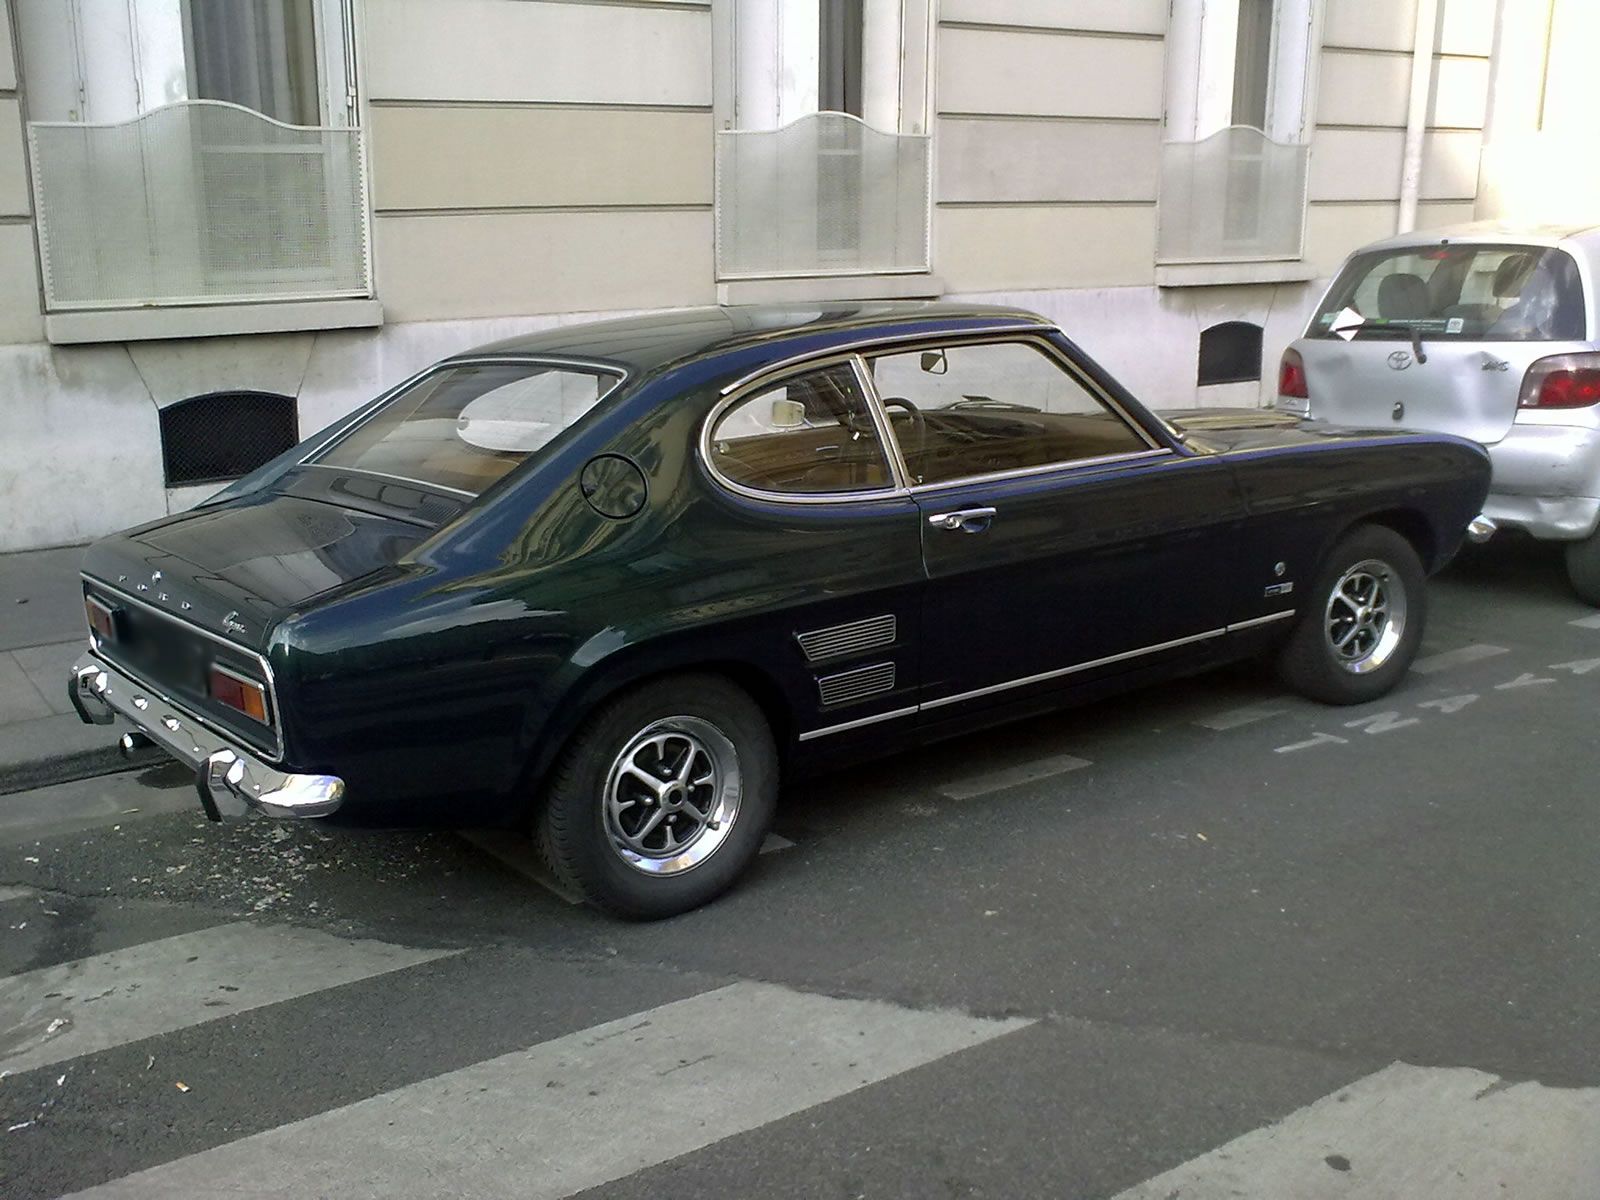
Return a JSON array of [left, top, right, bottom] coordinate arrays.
[[1115, 1062, 1600, 1200]]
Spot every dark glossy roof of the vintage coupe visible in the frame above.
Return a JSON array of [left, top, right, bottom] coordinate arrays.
[[453, 301, 1050, 374]]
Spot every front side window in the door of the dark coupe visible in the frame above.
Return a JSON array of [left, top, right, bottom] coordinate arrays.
[[869, 342, 1150, 485]]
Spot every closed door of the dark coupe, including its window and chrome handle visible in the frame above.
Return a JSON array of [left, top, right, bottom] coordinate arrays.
[[867, 338, 1242, 710]]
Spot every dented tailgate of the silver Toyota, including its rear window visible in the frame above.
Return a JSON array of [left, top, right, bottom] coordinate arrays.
[[1280, 242, 1592, 445]]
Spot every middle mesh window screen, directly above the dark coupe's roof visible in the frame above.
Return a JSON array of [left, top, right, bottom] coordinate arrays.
[[717, 112, 928, 278]]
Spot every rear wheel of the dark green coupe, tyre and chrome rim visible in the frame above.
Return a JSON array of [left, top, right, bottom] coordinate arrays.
[[534, 675, 778, 920]]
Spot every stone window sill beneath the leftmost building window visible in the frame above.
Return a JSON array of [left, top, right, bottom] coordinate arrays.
[[45, 299, 384, 346]]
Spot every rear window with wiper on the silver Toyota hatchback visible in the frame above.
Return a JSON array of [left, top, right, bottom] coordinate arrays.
[[1312, 245, 1587, 342]]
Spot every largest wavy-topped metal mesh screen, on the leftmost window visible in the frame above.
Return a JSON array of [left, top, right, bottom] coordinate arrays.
[[29, 101, 371, 310]]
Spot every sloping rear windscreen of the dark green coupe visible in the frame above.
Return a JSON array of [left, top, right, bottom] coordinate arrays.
[[315, 362, 619, 496]]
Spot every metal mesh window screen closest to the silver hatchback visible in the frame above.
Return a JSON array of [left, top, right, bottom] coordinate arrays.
[[1157, 125, 1310, 262]]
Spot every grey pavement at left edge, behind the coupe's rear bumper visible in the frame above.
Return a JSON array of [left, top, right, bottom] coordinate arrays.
[[0, 546, 133, 794]]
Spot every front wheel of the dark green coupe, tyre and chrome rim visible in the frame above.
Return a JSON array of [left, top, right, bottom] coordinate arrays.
[[1277, 525, 1427, 704]]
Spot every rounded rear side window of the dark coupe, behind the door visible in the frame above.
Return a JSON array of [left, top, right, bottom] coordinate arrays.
[[709, 363, 893, 494]]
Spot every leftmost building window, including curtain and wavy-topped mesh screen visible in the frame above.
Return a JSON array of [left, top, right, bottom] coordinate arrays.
[[16, 0, 371, 312]]
